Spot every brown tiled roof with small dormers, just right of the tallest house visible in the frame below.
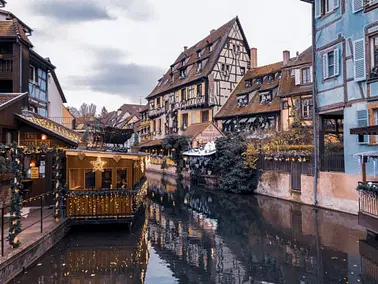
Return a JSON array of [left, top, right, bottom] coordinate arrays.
[[215, 61, 283, 119]]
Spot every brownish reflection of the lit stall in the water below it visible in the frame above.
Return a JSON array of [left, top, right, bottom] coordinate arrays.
[[15, 216, 149, 284]]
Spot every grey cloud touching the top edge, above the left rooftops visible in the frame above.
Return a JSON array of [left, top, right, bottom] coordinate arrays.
[[30, 0, 153, 24]]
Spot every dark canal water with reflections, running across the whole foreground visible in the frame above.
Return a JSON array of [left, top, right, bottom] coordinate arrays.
[[8, 171, 378, 284]]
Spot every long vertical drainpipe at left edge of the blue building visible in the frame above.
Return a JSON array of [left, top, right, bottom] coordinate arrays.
[[312, 1, 319, 206]]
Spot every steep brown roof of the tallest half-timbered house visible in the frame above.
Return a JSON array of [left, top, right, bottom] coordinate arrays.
[[147, 17, 249, 98]]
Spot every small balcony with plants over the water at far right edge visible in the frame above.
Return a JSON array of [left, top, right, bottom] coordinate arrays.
[[357, 182, 378, 234]]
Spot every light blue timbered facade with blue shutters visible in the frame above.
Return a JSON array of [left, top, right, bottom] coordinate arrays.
[[315, 0, 378, 174]]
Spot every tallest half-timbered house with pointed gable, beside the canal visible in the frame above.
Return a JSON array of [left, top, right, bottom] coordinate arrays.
[[147, 17, 250, 145]]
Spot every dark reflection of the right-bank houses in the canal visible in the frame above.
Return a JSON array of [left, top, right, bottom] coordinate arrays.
[[147, 171, 378, 284]]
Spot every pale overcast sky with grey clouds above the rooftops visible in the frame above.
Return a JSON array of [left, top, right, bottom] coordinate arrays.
[[7, 0, 311, 111]]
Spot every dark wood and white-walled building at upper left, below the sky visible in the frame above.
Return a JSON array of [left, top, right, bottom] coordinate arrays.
[[0, 10, 67, 118]]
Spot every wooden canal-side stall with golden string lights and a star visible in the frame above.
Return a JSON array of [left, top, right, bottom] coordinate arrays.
[[66, 150, 148, 224]]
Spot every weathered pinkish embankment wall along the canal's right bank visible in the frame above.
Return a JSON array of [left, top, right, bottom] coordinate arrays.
[[256, 171, 376, 215]]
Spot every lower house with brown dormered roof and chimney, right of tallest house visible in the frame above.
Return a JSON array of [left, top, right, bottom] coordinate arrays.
[[215, 49, 283, 138]]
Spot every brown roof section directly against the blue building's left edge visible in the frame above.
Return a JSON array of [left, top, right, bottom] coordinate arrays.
[[279, 47, 312, 97]]
